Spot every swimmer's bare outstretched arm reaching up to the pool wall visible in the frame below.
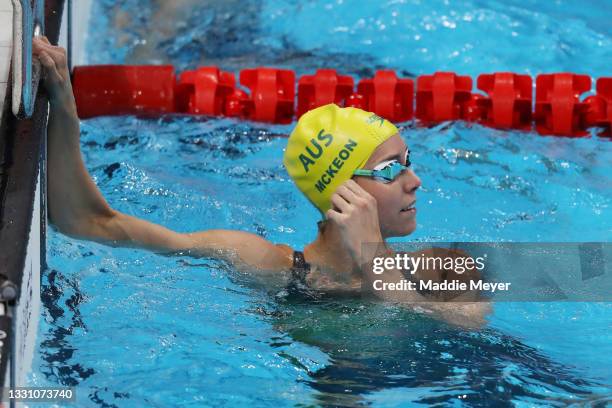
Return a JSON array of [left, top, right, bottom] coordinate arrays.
[[33, 37, 291, 269]]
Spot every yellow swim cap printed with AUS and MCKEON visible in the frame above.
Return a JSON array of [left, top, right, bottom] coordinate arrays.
[[283, 104, 398, 214]]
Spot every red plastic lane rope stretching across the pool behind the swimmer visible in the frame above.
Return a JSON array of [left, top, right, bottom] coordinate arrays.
[[73, 65, 612, 137]]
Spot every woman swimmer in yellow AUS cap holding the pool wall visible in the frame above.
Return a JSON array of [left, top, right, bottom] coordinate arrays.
[[33, 37, 489, 327]]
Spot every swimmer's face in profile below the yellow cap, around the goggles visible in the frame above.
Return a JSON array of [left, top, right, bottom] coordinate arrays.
[[354, 134, 421, 238]]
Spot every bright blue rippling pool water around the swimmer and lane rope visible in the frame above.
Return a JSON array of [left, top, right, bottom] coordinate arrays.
[[32, 0, 612, 407]]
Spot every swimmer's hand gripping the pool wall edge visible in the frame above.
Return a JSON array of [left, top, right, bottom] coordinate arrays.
[[32, 37, 75, 108]]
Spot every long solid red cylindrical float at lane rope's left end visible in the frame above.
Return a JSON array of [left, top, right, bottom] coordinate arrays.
[[72, 65, 175, 119]]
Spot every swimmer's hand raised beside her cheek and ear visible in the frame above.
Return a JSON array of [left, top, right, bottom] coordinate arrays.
[[325, 180, 383, 265]]
